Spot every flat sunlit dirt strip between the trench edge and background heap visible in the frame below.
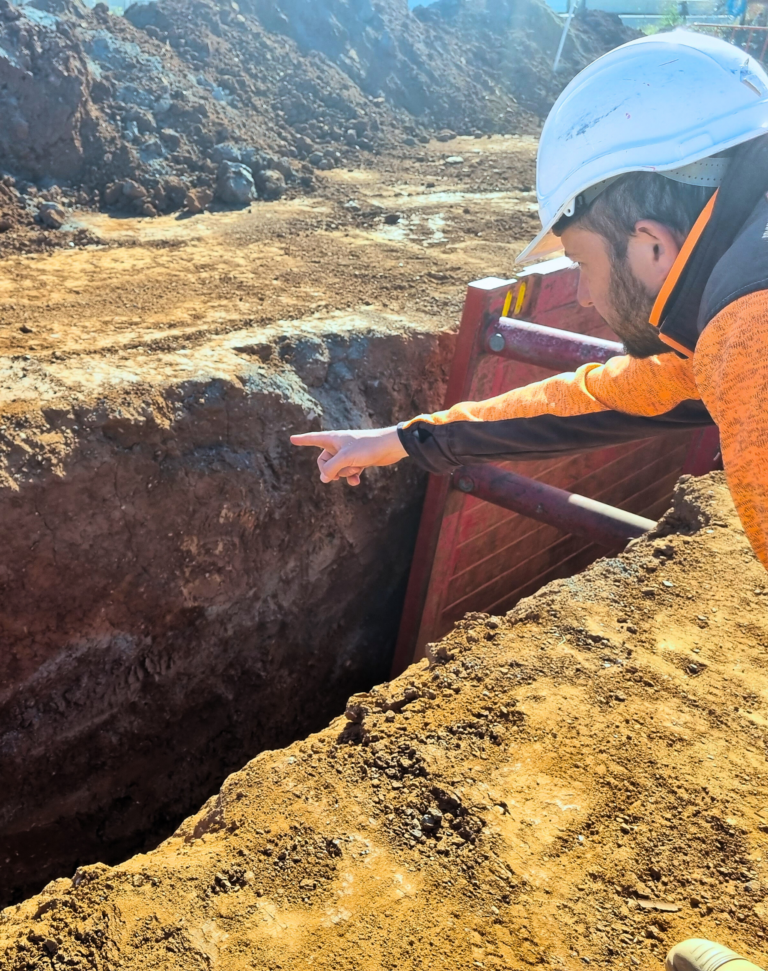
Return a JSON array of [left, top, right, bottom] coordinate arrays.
[[0, 136, 538, 364]]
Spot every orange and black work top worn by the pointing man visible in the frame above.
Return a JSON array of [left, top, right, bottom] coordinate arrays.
[[399, 136, 768, 567]]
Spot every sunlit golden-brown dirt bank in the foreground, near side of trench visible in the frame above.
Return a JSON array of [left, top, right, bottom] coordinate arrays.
[[0, 474, 768, 971]]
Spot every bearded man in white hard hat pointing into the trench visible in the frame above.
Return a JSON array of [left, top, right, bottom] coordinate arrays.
[[292, 30, 768, 567]]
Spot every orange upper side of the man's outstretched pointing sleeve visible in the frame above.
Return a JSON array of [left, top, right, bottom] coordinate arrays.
[[405, 354, 700, 427]]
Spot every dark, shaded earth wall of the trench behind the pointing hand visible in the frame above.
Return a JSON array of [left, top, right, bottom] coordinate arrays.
[[0, 314, 454, 906]]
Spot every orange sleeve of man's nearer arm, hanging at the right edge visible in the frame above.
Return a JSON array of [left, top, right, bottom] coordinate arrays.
[[693, 290, 768, 568]]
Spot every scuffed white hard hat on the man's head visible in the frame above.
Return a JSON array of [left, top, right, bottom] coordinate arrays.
[[518, 29, 768, 263]]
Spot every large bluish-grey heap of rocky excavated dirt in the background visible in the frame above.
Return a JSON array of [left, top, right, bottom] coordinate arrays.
[[0, 0, 633, 222]]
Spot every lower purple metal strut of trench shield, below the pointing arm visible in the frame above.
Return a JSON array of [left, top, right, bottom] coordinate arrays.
[[452, 465, 656, 548]]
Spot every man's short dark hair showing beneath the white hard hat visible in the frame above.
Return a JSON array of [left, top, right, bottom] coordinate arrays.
[[553, 172, 715, 260]]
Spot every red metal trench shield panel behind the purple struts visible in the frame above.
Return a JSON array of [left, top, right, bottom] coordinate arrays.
[[393, 260, 717, 674]]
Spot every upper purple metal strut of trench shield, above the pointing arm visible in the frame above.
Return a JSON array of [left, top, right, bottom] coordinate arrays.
[[484, 317, 624, 371]]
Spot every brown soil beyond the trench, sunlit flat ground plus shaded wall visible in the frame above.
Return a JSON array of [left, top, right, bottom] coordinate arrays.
[[0, 138, 536, 904]]
